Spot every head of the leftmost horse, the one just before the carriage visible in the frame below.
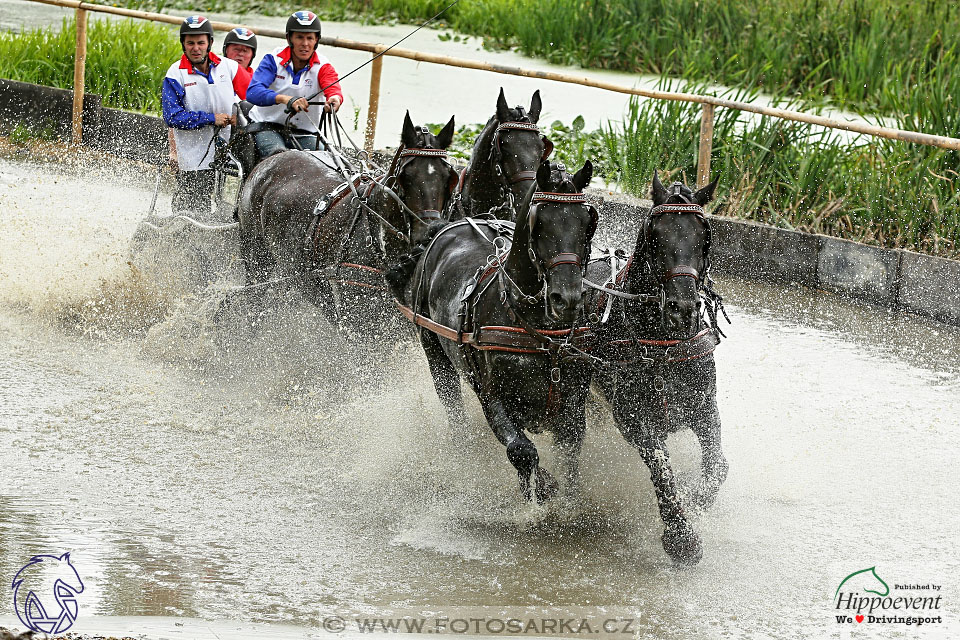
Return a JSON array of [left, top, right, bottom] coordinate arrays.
[[385, 111, 459, 246]]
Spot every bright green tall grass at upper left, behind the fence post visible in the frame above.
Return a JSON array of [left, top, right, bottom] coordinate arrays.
[[0, 19, 182, 112]]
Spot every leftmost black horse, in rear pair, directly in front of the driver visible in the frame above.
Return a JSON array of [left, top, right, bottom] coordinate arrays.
[[238, 113, 458, 333]]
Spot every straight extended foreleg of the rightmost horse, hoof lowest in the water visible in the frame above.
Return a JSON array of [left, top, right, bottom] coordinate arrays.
[[617, 394, 703, 565]]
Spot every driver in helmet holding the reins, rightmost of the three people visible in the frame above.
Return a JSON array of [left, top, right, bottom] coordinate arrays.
[[247, 11, 343, 158]]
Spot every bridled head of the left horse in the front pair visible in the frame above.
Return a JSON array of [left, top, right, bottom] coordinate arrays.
[[514, 160, 597, 326]]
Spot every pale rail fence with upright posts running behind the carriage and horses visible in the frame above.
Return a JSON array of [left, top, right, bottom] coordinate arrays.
[[28, 0, 960, 187]]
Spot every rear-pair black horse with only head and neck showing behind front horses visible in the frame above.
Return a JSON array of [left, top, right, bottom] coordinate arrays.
[[451, 88, 553, 220]]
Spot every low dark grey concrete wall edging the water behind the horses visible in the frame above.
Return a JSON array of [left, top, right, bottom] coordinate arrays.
[[0, 79, 960, 325]]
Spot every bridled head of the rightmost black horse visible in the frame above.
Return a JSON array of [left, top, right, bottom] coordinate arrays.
[[634, 172, 717, 337]]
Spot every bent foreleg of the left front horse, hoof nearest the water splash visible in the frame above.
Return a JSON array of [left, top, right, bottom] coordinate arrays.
[[480, 393, 560, 504]]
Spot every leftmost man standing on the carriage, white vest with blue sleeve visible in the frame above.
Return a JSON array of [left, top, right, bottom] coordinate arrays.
[[161, 16, 244, 214]]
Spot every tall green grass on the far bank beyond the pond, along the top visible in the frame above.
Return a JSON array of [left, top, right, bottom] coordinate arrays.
[[105, 0, 960, 113]]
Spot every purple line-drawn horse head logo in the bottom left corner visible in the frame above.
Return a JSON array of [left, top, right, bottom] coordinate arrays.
[[11, 553, 83, 634]]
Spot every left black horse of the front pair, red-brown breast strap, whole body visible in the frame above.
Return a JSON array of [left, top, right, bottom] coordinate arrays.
[[407, 162, 597, 501]]
